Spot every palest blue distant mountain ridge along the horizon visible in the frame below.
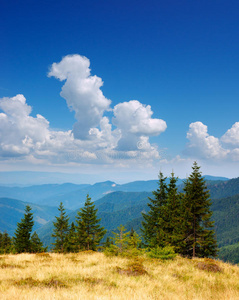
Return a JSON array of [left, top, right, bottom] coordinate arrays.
[[0, 176, 230, 210]]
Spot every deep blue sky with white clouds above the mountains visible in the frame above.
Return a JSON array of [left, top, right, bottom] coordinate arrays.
[[0, 0, 239, 182]]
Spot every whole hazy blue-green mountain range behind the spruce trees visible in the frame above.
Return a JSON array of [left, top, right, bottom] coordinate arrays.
[[0, 177, 239, 262]]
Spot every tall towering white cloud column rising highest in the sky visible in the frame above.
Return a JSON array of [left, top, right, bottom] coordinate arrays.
[[48, 55, 111, 139]]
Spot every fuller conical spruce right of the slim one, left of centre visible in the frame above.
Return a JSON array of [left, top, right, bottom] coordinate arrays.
[[76, 195, 106, 251]]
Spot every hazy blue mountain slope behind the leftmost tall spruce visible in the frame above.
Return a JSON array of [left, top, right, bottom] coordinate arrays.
[[0, 198, 72, 235]]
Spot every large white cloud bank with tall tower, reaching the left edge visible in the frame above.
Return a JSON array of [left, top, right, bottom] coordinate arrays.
[[0, 55, 167, 165]]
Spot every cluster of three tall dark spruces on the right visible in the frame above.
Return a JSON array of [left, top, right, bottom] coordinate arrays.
[[142, 162, 217, 257]]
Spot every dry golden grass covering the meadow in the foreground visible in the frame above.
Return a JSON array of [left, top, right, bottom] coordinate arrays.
[[0, 252, 239, 300]]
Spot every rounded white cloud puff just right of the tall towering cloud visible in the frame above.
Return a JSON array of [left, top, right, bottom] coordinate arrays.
[[113, 100, 167, 150]]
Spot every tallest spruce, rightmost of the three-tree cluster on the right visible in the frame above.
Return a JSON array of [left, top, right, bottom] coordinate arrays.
[[182, 162, 217, 257]]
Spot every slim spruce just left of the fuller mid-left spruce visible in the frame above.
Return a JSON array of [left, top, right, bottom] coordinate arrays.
[[51, 202, 69, 253]]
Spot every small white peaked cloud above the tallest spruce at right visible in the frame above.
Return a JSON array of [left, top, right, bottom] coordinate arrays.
[[185, 122, 229, 159]]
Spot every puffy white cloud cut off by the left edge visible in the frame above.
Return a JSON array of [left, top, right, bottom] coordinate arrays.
[[0, 95, 49, 156]]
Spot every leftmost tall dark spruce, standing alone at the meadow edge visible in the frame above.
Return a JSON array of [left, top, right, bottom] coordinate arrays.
[[13, 205, 34, 253]]
